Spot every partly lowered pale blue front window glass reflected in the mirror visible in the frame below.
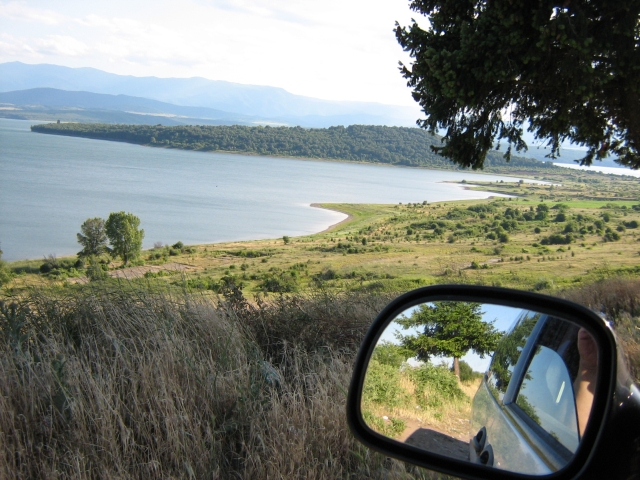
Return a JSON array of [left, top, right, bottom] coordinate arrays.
[[516, 345, 580, 452]]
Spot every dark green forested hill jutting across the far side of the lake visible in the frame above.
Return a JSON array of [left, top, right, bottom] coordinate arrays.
[[31, 123, 551, 168]]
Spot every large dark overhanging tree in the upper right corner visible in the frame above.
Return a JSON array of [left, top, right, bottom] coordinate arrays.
[[396, 0, 640, 169]]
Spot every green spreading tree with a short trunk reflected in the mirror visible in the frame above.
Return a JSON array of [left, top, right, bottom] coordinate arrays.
[[397, 302, 502, 378]]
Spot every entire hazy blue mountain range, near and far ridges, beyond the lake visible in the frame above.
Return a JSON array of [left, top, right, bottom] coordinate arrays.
[[0, 62, 419, 127]]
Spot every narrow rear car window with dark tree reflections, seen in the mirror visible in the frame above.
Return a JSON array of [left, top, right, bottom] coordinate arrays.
[[487, 311, 540, 402]]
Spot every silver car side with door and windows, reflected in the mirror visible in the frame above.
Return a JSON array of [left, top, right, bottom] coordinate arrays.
[[470, 312, 580, 474]]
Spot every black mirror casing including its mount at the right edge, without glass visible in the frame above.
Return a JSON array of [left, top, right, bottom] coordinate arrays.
[[347, 285, 640, 479]]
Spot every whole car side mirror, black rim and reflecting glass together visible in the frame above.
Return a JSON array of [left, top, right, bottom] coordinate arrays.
[[347, 285, 616, 479]]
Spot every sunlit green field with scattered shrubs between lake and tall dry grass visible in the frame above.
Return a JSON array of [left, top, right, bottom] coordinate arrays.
[[5, 169, 640, 295]]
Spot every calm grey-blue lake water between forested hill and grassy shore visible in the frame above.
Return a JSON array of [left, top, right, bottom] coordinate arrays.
[[0, 119, 517, 261]]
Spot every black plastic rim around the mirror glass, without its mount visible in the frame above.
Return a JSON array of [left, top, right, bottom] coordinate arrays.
[[347, 285, 616, 480]]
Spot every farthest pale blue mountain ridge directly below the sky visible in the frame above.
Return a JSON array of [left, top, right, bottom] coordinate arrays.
[[0, 62, 419, 127]]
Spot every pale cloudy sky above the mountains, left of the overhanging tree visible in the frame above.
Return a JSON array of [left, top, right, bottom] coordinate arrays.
[[0, 0, 426, 109]]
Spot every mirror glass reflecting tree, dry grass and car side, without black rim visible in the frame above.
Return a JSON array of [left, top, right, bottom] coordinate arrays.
[[361, 301, 598, 475]]
